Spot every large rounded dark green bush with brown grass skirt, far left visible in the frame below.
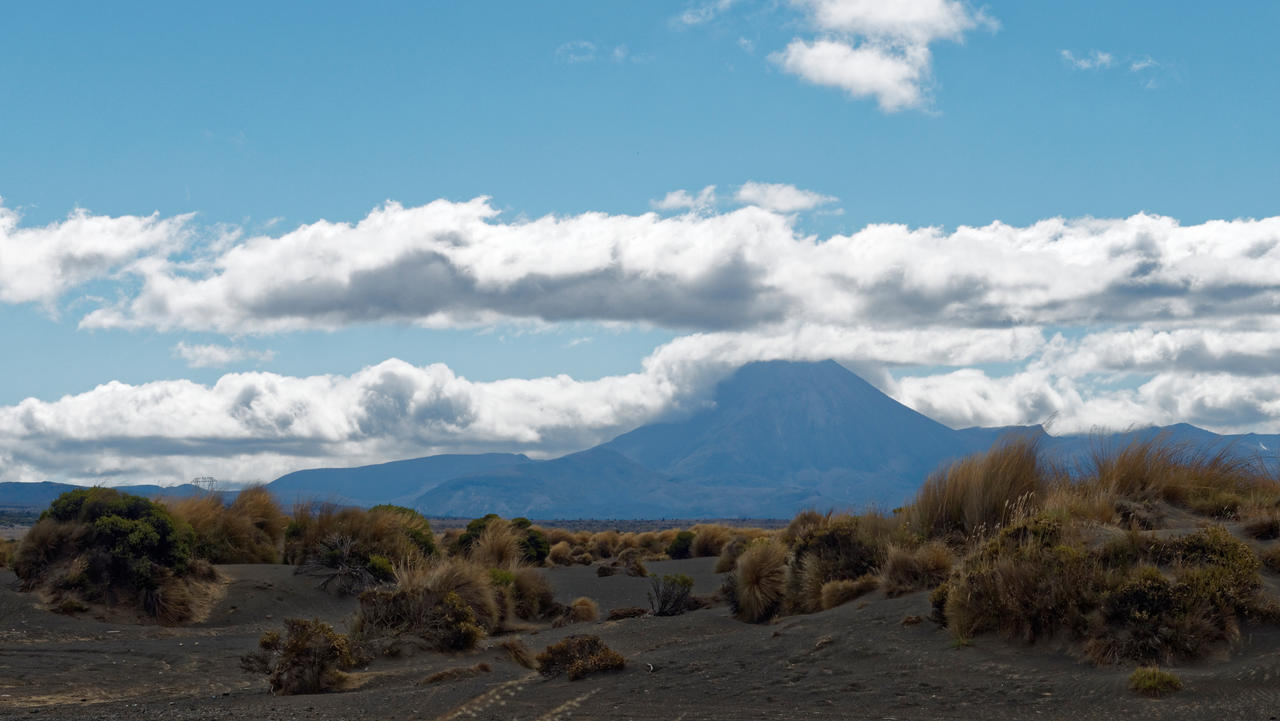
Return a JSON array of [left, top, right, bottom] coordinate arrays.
[[13, 488, 204, 624]]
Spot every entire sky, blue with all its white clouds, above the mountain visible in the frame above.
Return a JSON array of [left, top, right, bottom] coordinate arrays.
[[0, 0, 1280, 482]]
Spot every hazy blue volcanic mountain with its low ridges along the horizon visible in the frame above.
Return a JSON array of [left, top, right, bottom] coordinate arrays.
[[10, 361, 1280, 519]]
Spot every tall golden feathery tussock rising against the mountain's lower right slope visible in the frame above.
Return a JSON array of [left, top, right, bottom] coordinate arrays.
[[905, 435, 1050, 540]]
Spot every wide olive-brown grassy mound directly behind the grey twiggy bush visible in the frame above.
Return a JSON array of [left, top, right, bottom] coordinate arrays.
[[284, 505, 435, 593]]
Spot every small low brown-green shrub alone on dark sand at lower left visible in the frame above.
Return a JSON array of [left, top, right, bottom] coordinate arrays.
[[241, 619, 362, 695]]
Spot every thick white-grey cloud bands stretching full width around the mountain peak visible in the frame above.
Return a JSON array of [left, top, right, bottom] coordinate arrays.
[[0, 194, 1280, 482]]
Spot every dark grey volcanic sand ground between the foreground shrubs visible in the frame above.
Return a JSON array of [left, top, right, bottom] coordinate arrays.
[[0, 558, 1280, 721]]
